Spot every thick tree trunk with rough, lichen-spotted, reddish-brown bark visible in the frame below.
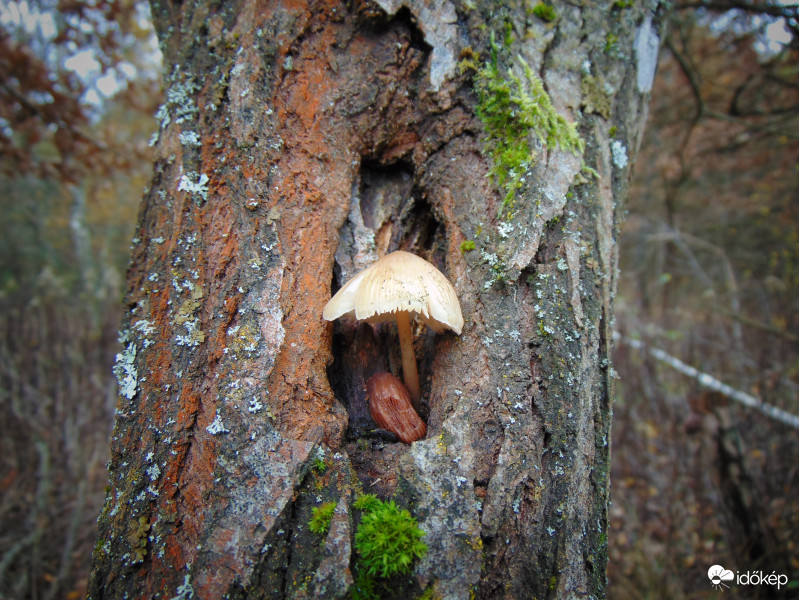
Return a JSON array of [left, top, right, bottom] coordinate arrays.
[[90, 0, 660, 599]]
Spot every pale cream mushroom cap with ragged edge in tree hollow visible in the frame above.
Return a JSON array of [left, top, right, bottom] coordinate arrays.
[[322, 250, 463, 334]]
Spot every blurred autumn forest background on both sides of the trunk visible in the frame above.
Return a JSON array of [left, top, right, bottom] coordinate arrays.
[[0, 0, 799, 599]]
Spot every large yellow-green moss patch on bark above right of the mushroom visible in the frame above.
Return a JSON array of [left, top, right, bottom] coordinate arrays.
[[475, 36, 585, 213]]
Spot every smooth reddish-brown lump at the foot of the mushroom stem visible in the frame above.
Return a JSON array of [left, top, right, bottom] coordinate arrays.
[[366, 373, 427, 444]]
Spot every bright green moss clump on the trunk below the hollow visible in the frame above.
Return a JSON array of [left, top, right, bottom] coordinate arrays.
[[353, 494, 427, 577]]
